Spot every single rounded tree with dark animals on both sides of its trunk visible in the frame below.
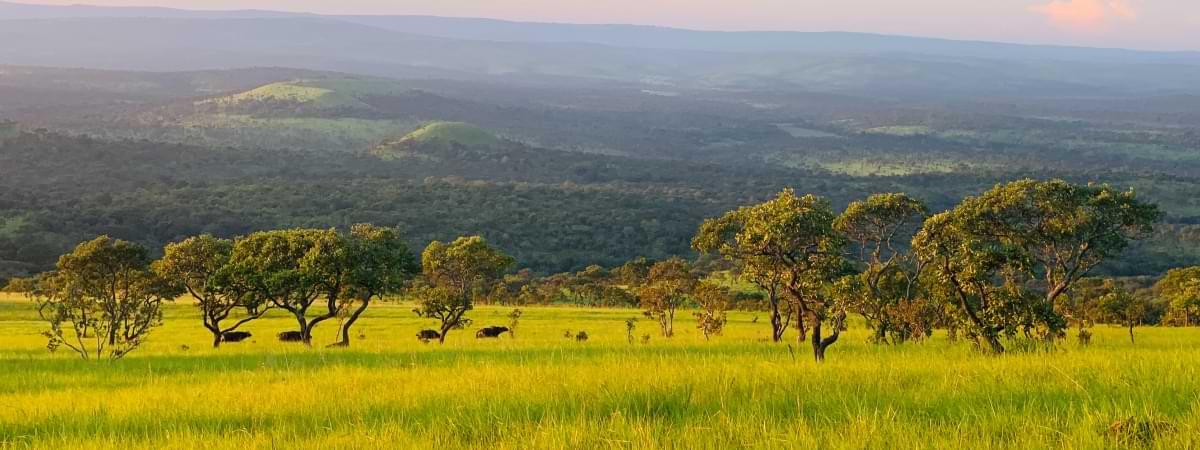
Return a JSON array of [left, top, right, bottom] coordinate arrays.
[[413, 236, 515, 342]]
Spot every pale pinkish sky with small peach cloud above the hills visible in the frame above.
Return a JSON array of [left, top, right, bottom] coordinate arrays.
[[13, 0, 1200, 50]]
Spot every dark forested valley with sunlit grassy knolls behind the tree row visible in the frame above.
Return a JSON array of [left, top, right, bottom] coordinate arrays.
[[0, 66, 1200, 277]]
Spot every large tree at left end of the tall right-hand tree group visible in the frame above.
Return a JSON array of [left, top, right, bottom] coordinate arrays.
[[692, 190, 846, 361]]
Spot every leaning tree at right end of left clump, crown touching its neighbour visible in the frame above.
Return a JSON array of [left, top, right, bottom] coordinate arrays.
[[328, 223, 419, 347]]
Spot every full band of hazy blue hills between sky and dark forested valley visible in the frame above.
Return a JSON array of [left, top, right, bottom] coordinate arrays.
[[0, 4, 1200, 98]]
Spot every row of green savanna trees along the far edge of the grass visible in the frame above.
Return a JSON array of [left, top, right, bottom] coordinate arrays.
[[14, 179, 1200, 361]]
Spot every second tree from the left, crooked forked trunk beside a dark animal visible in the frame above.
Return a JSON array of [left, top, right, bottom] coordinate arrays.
[[151, 234, 269, 348]]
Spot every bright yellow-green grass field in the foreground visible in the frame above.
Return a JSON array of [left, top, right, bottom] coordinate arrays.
[[0, 296, 1200, 449]]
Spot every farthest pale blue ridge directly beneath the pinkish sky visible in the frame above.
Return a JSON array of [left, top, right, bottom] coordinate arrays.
[[0, 1, 1200, 64]]
